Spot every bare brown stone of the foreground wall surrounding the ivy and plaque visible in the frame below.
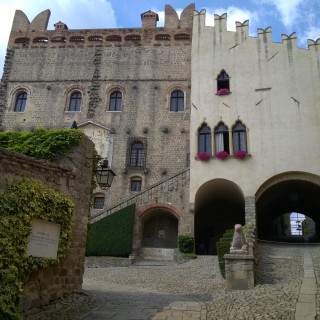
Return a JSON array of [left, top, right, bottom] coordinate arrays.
[[0, 138, 94, 310]]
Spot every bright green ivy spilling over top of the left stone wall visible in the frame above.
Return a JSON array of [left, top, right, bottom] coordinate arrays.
[[0, 129, 84, 161]]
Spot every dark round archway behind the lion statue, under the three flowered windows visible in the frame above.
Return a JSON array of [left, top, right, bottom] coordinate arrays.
[[194, 179, 245, 255]]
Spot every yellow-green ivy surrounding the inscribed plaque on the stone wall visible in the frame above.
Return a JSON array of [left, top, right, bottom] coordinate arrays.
[[0, 178, 74, 320]]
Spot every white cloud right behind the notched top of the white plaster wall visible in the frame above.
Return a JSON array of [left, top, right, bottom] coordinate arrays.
[[206, 6, 259, 31]]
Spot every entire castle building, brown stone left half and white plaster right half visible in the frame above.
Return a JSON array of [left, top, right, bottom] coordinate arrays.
[[0, 4, 320, 258]]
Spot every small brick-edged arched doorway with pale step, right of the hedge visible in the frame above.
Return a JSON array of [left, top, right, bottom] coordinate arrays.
[[140, 204, 180, 260]]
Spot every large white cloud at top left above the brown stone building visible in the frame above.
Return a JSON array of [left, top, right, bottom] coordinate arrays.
[[0, 0, 117, 74]]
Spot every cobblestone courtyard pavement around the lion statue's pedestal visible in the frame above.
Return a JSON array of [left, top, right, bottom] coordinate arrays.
[[25, 243, 320, 320]]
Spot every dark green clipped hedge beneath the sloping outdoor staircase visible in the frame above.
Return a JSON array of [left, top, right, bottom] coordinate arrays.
[[86, 204, 135, 257]]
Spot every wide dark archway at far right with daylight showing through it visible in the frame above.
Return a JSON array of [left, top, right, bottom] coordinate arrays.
[[256, 172, 320, 242]]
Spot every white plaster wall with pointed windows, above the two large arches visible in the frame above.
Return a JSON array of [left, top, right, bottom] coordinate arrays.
[[190, 12, 320, 203]]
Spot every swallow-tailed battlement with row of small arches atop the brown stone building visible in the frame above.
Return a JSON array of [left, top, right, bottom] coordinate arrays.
[[8, 4, 194, 48]]
